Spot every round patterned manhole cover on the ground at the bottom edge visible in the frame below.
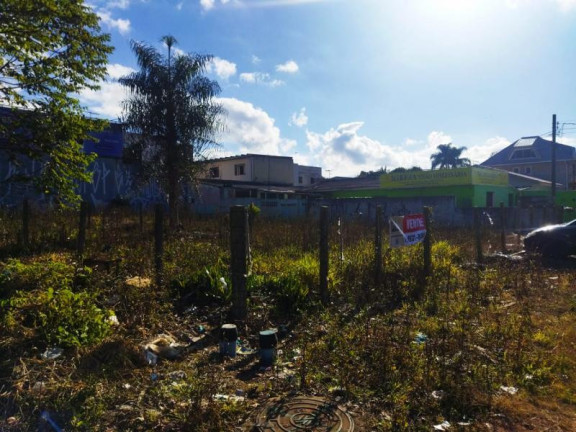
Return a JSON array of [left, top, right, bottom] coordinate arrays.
[[253, 396, 354, 432]]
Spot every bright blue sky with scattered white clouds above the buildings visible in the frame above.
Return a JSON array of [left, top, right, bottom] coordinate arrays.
[[80, 0, 576, 178]]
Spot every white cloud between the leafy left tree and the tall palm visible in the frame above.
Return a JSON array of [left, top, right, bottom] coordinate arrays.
[[79, 64, 134, 120]]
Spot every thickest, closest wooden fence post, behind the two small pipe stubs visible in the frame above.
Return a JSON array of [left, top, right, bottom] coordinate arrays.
[[230, 206, 250, 321]]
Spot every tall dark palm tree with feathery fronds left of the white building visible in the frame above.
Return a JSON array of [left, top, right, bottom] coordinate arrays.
[[119, 36, 223, 226]]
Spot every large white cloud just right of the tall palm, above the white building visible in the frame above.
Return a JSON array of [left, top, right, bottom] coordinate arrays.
[[218, 98, 296, 155]]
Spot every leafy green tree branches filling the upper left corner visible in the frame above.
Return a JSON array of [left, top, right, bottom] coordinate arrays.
[[0, 0, 113, 205]]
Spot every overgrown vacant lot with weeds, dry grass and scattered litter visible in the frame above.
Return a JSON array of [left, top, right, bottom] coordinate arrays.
[[0, 209, 576, 431]]
